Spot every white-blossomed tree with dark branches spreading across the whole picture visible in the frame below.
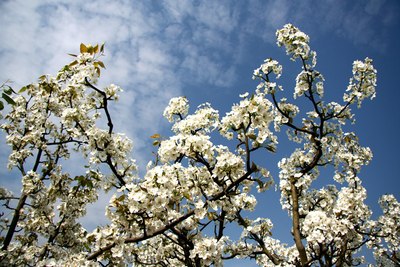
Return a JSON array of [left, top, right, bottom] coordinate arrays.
[[0, 24, 400, 266]]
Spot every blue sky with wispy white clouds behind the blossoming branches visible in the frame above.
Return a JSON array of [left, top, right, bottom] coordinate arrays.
[[0, 0, 400, 266]]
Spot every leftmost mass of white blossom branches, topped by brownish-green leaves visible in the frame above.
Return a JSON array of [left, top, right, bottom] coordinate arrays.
[[0, 45, 136, 265]]
